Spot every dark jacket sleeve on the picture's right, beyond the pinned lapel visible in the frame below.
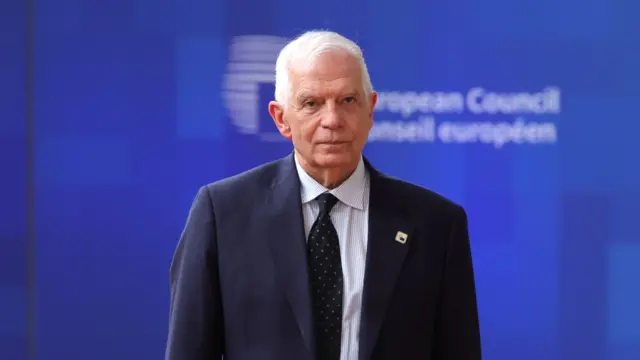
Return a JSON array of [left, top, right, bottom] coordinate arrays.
[[433, 207, 482, 360]]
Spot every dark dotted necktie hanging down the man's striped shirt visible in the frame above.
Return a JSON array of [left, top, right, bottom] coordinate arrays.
[[307, 193, 342, 360]]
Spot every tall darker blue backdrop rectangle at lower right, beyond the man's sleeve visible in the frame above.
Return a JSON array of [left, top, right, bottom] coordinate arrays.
[[557, 192, 612, 360]]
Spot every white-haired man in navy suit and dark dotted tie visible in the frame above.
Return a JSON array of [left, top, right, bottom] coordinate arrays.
[[166, 31, 481, 360]]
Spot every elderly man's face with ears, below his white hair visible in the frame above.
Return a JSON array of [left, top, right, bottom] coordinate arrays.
[[269, 52, 377, 169]]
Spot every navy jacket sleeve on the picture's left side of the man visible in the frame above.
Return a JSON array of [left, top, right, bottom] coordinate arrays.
[[165, 187, 224, 360]]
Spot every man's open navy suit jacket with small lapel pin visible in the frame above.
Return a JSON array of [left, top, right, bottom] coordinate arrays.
[[166, 155, 481, 360]]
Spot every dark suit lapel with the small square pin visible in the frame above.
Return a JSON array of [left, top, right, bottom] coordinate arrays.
[[359, 162, 413, 360]]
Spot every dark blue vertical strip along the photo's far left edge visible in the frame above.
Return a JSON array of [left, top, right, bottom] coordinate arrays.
[[0, 1, 30, 360]]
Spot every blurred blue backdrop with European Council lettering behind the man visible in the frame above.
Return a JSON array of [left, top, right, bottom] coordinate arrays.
[[0, 0, 640, 360]]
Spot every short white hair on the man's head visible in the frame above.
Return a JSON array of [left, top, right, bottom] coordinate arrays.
[[275, 30, 373, 107]]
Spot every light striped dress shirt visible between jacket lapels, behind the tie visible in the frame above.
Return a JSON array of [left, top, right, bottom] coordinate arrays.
[[296, 157, 370, 360]]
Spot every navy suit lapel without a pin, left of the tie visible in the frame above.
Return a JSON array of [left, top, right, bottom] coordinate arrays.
[[267, 155, 315, 355]]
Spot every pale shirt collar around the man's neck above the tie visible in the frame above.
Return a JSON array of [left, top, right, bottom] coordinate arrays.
[[294, 155, 368, 210]]
